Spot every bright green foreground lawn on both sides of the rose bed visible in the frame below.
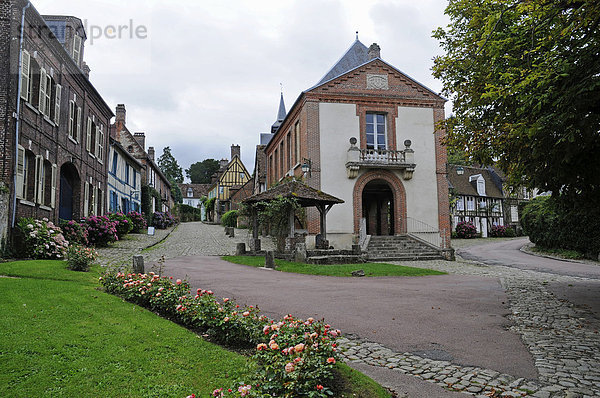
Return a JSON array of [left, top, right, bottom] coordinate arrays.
[[0, 261, 390, 398]]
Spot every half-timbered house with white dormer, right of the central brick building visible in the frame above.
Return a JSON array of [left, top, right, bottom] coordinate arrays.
[[448, 165, 507, 238]]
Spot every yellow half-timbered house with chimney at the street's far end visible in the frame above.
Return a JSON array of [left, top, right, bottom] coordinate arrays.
[[208, 145, 251, 222]]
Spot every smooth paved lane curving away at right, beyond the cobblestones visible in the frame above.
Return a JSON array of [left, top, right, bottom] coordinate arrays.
[[457, 238, 600, 279]]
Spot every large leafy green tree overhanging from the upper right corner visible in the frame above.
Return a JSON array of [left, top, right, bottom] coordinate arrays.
[[433, 0, 600, 200]]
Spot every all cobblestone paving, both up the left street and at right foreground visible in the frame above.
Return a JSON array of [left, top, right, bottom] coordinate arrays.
[[100, 227, 600, 398]]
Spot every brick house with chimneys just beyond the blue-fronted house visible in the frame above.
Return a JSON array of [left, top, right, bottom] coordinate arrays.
[[111, 104, 175, 212]]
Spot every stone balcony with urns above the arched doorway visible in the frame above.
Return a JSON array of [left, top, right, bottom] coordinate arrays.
[[346, 137, 417, 180]]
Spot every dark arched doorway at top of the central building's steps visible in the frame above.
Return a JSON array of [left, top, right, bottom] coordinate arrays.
[[362, 180, 396, 235]]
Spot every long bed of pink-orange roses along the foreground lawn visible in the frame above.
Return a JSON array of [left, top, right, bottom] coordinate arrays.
[[100, 272, 341, 397]]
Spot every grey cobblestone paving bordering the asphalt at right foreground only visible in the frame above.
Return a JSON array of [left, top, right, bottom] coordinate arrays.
[[340, 258, 600, 398]]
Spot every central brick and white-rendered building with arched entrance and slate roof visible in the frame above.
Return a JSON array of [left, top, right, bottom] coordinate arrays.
[[265, 38, 450, 249]]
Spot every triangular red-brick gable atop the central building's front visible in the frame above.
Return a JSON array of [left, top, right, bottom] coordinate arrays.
[[307, 58, 445, 101]]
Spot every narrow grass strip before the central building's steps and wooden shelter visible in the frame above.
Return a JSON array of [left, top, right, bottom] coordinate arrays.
[[222, 256, 445, 276]]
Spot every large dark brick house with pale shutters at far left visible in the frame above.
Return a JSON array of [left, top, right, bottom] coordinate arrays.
[[0, 0, 113, 246]]
